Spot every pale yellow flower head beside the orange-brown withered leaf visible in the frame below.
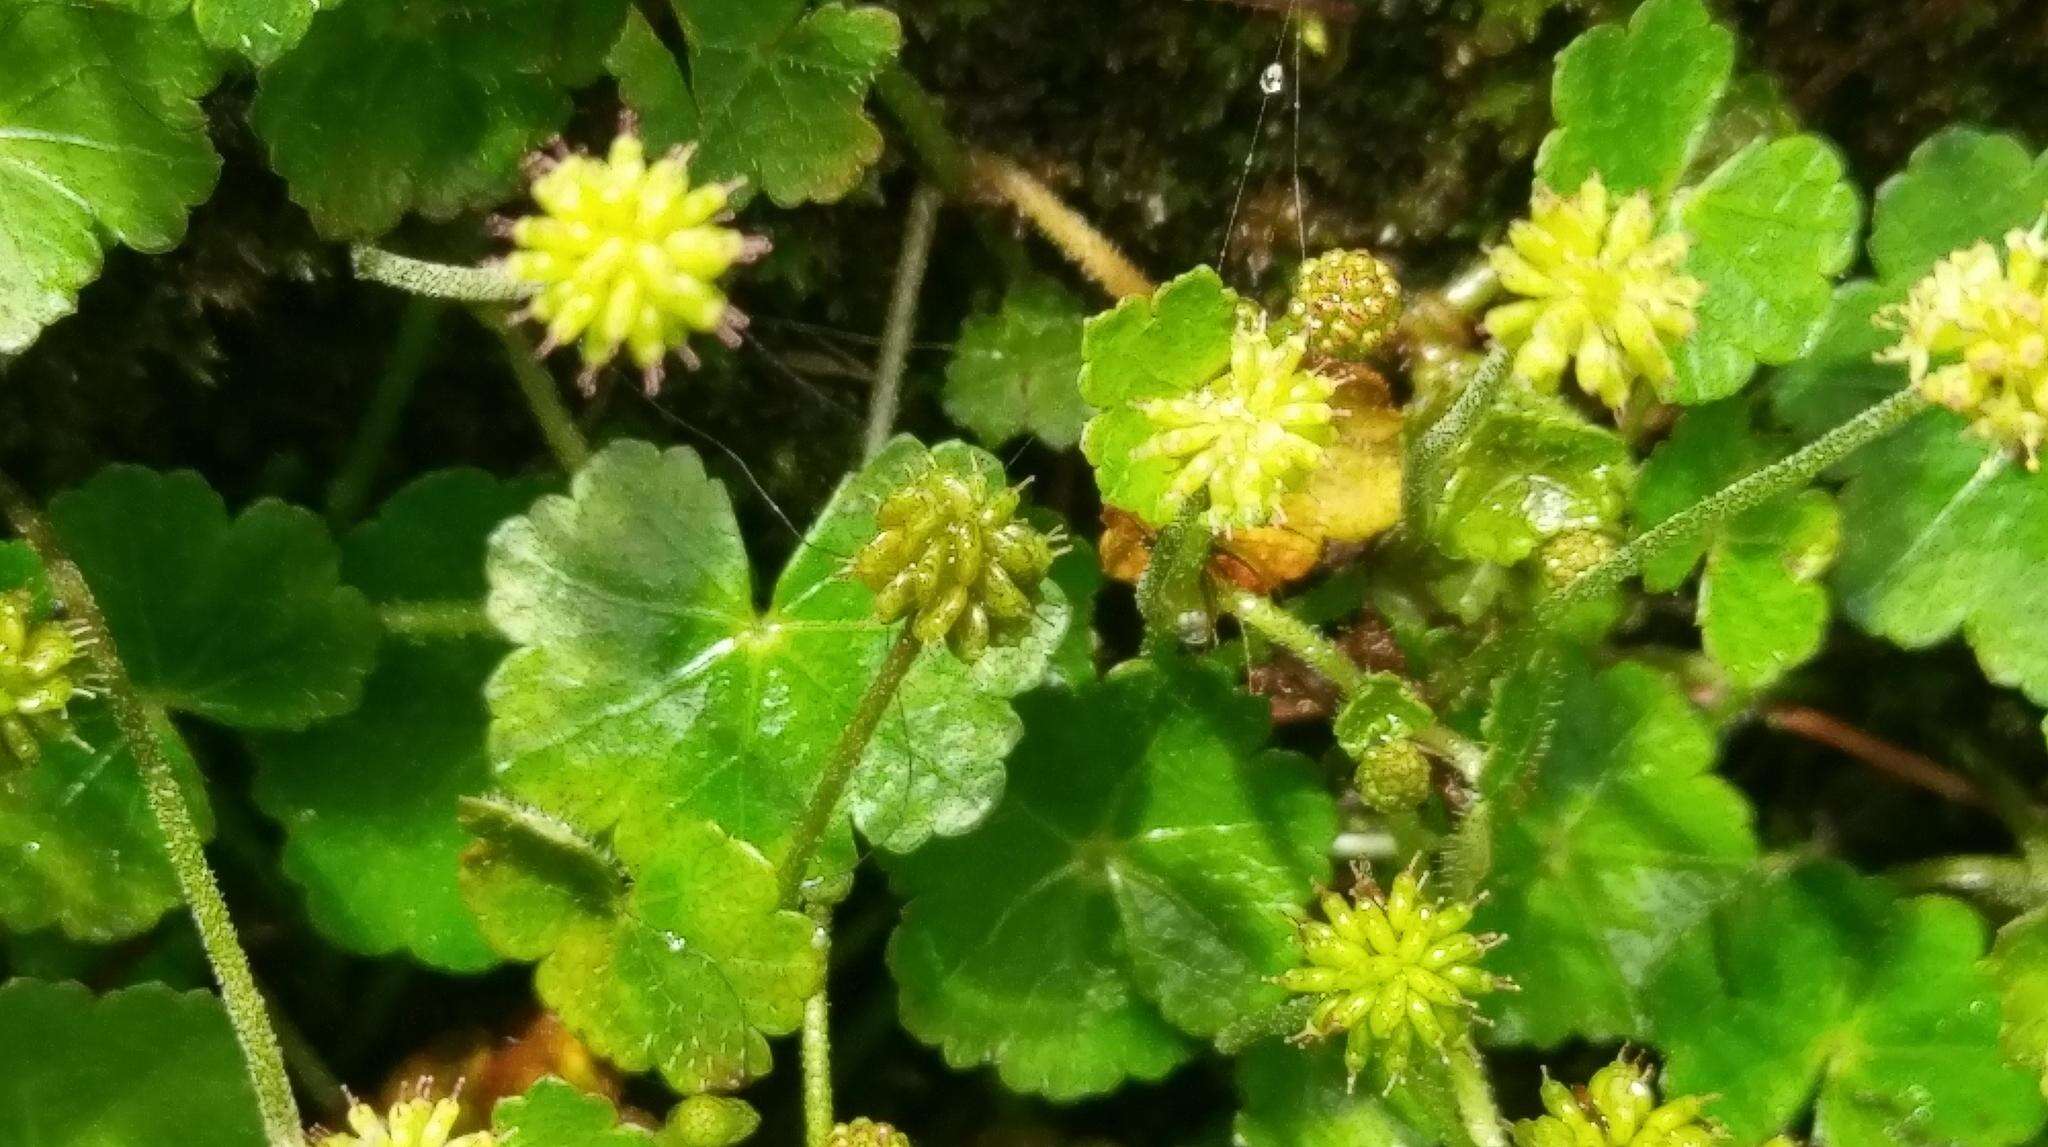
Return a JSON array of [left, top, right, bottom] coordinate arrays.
[[1130, 322, 1337, 533]]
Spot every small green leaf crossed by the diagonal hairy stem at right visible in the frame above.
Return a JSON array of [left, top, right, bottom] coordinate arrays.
[[1636, 401, 1841, 688]]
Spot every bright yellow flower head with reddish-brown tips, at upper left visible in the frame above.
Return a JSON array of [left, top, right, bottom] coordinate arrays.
[[506, 133, 768, 391]]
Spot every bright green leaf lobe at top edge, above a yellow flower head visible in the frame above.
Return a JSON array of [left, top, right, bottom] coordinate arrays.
[[1536, 0, 1735, 199]]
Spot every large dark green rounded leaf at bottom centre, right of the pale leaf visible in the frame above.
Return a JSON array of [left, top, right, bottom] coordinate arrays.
[[889, 664, 1335, 1098]]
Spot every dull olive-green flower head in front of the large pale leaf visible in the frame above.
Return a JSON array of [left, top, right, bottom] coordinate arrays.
[[852, 459, 1059, 662]]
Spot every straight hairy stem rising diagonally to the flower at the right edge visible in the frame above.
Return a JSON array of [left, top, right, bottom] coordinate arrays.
[[1532, 389, 1927, 631]]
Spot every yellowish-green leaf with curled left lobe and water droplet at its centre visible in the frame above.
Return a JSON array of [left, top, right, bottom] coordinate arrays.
[[463, 805, 825, 1092]]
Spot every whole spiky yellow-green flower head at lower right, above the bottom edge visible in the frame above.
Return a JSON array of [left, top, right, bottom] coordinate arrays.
[[1280, 870, 1509, 1086]]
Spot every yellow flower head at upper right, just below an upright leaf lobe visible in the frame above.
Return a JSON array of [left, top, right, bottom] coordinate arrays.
[[1487, 176, 1706, 410]]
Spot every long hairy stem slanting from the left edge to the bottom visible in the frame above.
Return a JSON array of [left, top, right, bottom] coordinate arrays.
[[0, 475, 303, 1147]]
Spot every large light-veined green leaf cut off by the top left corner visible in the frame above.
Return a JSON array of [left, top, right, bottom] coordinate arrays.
[[0, 0, 221, 356]]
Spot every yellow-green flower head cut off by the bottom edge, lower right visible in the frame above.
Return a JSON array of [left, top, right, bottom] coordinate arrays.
[[1516, 1059, 1729, 1147]]
